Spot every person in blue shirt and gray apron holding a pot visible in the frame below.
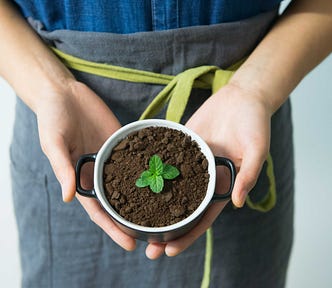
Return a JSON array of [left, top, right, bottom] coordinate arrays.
[[0, 0, 332, 287]]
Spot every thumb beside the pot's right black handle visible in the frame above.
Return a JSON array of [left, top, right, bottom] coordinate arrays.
[[232, 150, 265, 208]]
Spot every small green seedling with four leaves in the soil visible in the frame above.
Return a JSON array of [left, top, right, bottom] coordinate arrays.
[[136, 155, 180, 193]]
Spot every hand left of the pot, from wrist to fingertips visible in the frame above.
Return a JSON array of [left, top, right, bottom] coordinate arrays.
[[35, 81, 136, 250]]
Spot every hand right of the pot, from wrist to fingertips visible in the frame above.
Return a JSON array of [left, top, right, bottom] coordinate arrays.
[[146, 84, 272, 259]]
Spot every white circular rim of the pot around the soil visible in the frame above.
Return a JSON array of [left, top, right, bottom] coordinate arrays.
[[94, 119, 216, 233]]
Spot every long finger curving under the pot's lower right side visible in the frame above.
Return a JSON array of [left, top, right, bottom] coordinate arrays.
[[165, 202, 227, 257]]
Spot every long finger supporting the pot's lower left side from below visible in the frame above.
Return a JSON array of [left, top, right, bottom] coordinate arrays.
[[76, 194, 136, 251]]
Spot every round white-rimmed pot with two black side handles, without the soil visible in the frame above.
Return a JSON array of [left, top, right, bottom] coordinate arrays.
[[76, 119, 236, 242]]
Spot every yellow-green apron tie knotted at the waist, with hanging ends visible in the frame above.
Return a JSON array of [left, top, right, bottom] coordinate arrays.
[[51, 48, 276, 288]]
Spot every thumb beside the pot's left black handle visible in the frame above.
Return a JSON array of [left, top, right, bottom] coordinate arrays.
[[43, 138, 76, 202]]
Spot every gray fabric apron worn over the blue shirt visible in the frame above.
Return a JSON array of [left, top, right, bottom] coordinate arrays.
[[11, 11, 294, 288]]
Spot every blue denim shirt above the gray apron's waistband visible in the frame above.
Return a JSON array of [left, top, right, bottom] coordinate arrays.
[[15, 0, 281, 33]]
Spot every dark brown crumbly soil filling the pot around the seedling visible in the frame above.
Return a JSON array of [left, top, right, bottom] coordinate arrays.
[[104, 127, 209, 227]]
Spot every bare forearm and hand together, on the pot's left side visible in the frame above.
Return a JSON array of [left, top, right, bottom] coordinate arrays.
[[0, 1, 136, 250]]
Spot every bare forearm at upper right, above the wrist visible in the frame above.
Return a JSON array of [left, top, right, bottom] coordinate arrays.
[[230, 0, 332, 113]]
